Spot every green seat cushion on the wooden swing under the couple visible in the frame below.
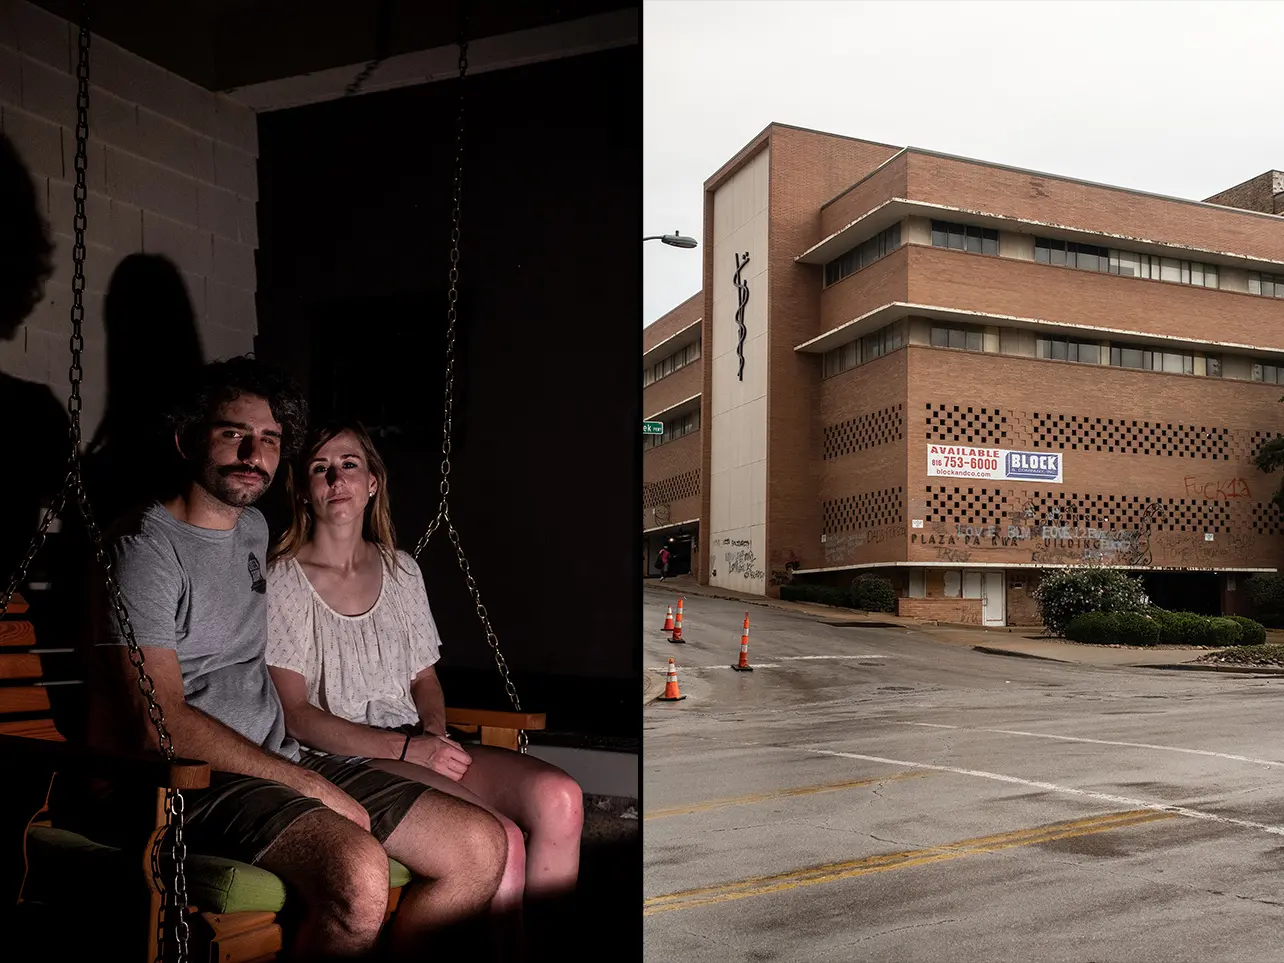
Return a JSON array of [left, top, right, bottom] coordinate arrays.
[[24, 826, 411, 913]]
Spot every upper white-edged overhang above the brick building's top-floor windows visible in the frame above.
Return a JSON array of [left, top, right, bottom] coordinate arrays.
[[794, 198, 1284, 271]]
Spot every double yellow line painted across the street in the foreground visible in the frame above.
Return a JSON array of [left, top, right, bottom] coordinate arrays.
[[642, 809, 1176, 915]]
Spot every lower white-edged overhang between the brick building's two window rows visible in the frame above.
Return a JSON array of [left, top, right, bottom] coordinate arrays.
[[794, 300, 1284, 360]]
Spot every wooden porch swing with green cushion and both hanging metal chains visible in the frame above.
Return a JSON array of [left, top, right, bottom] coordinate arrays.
[[0, 0, 544, 963]]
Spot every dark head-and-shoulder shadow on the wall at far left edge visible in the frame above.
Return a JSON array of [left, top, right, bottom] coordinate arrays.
[[0, 134, 69, 592]]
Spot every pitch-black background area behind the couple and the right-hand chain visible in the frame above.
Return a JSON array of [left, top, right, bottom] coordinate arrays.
[[256, 46, 642, 738]]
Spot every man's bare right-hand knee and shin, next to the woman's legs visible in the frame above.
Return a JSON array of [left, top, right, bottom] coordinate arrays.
[[374, 792, 507, 959]]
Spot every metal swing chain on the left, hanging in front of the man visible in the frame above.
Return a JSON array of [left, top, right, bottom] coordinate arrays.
[[0, 9, 190, 963]]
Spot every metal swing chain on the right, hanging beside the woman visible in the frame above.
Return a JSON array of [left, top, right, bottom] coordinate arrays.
[[415, 9, 529, 754]]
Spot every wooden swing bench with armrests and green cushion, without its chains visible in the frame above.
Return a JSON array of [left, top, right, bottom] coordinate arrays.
[[0, 596, 544, 963]]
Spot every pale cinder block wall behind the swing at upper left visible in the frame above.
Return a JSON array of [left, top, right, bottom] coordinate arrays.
[[0, 0, 258, 439]]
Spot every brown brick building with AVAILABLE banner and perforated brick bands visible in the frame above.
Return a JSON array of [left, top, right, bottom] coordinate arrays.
[[643, 125, 1284, 624]]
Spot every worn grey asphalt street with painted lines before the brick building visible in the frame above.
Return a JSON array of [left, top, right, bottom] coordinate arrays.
[[643, 588, 1284, 963]]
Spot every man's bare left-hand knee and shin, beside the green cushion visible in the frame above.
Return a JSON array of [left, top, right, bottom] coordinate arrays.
[[258, 809, 388, 960]]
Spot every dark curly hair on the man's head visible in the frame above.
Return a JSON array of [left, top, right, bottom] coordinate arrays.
[[168, 354, 308, 462]]
